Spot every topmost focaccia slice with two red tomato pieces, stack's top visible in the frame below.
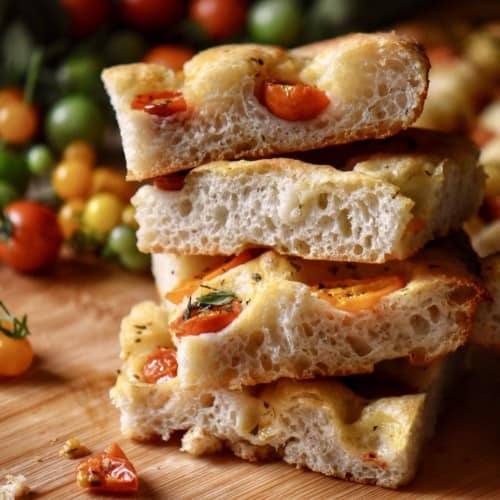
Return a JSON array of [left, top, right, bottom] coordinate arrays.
[[103, 34, 429, 180]]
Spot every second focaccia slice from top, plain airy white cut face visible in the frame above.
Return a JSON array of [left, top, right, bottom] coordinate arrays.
[[133, 130, 484, 262]]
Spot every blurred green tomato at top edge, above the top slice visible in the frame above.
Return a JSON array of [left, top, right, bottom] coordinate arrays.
[[248, 0, 302, 45]]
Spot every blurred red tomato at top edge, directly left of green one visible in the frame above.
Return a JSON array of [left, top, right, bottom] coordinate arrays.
[[189, 0, 247, 40]]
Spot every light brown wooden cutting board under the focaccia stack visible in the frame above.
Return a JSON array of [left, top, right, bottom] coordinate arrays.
[[0, 262, 500, 499]]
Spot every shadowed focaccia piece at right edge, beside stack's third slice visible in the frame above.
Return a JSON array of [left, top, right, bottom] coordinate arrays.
[[469, 254, 500, 351]]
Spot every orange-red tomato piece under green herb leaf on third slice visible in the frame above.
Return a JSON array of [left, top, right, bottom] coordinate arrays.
[[170, 299, 243, 337]]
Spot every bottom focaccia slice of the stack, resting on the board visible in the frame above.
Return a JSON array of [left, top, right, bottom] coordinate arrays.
[[111, 302, 460, 487]]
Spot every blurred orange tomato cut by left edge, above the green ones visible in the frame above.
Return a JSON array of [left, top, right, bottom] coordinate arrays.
[[0, 99, 38, 144]]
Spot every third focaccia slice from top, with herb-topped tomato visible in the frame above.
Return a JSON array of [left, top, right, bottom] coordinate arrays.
[[150, 238, 485, 389]]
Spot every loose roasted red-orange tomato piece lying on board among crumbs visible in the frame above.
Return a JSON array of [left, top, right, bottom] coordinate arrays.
[[76, 443, 139, 493]]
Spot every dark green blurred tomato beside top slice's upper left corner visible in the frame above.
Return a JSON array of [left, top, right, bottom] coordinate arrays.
[[56, 54, 103, 95]]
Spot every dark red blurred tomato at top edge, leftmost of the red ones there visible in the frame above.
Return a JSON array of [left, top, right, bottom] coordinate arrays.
[[62, 0, 111, 37]]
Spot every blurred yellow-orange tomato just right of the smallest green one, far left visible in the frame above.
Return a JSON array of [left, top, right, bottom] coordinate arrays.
[[52, 160, 92, 200]]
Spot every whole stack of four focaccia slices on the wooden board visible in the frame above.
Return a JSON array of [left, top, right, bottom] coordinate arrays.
[[103, 34, 486, 487]]
